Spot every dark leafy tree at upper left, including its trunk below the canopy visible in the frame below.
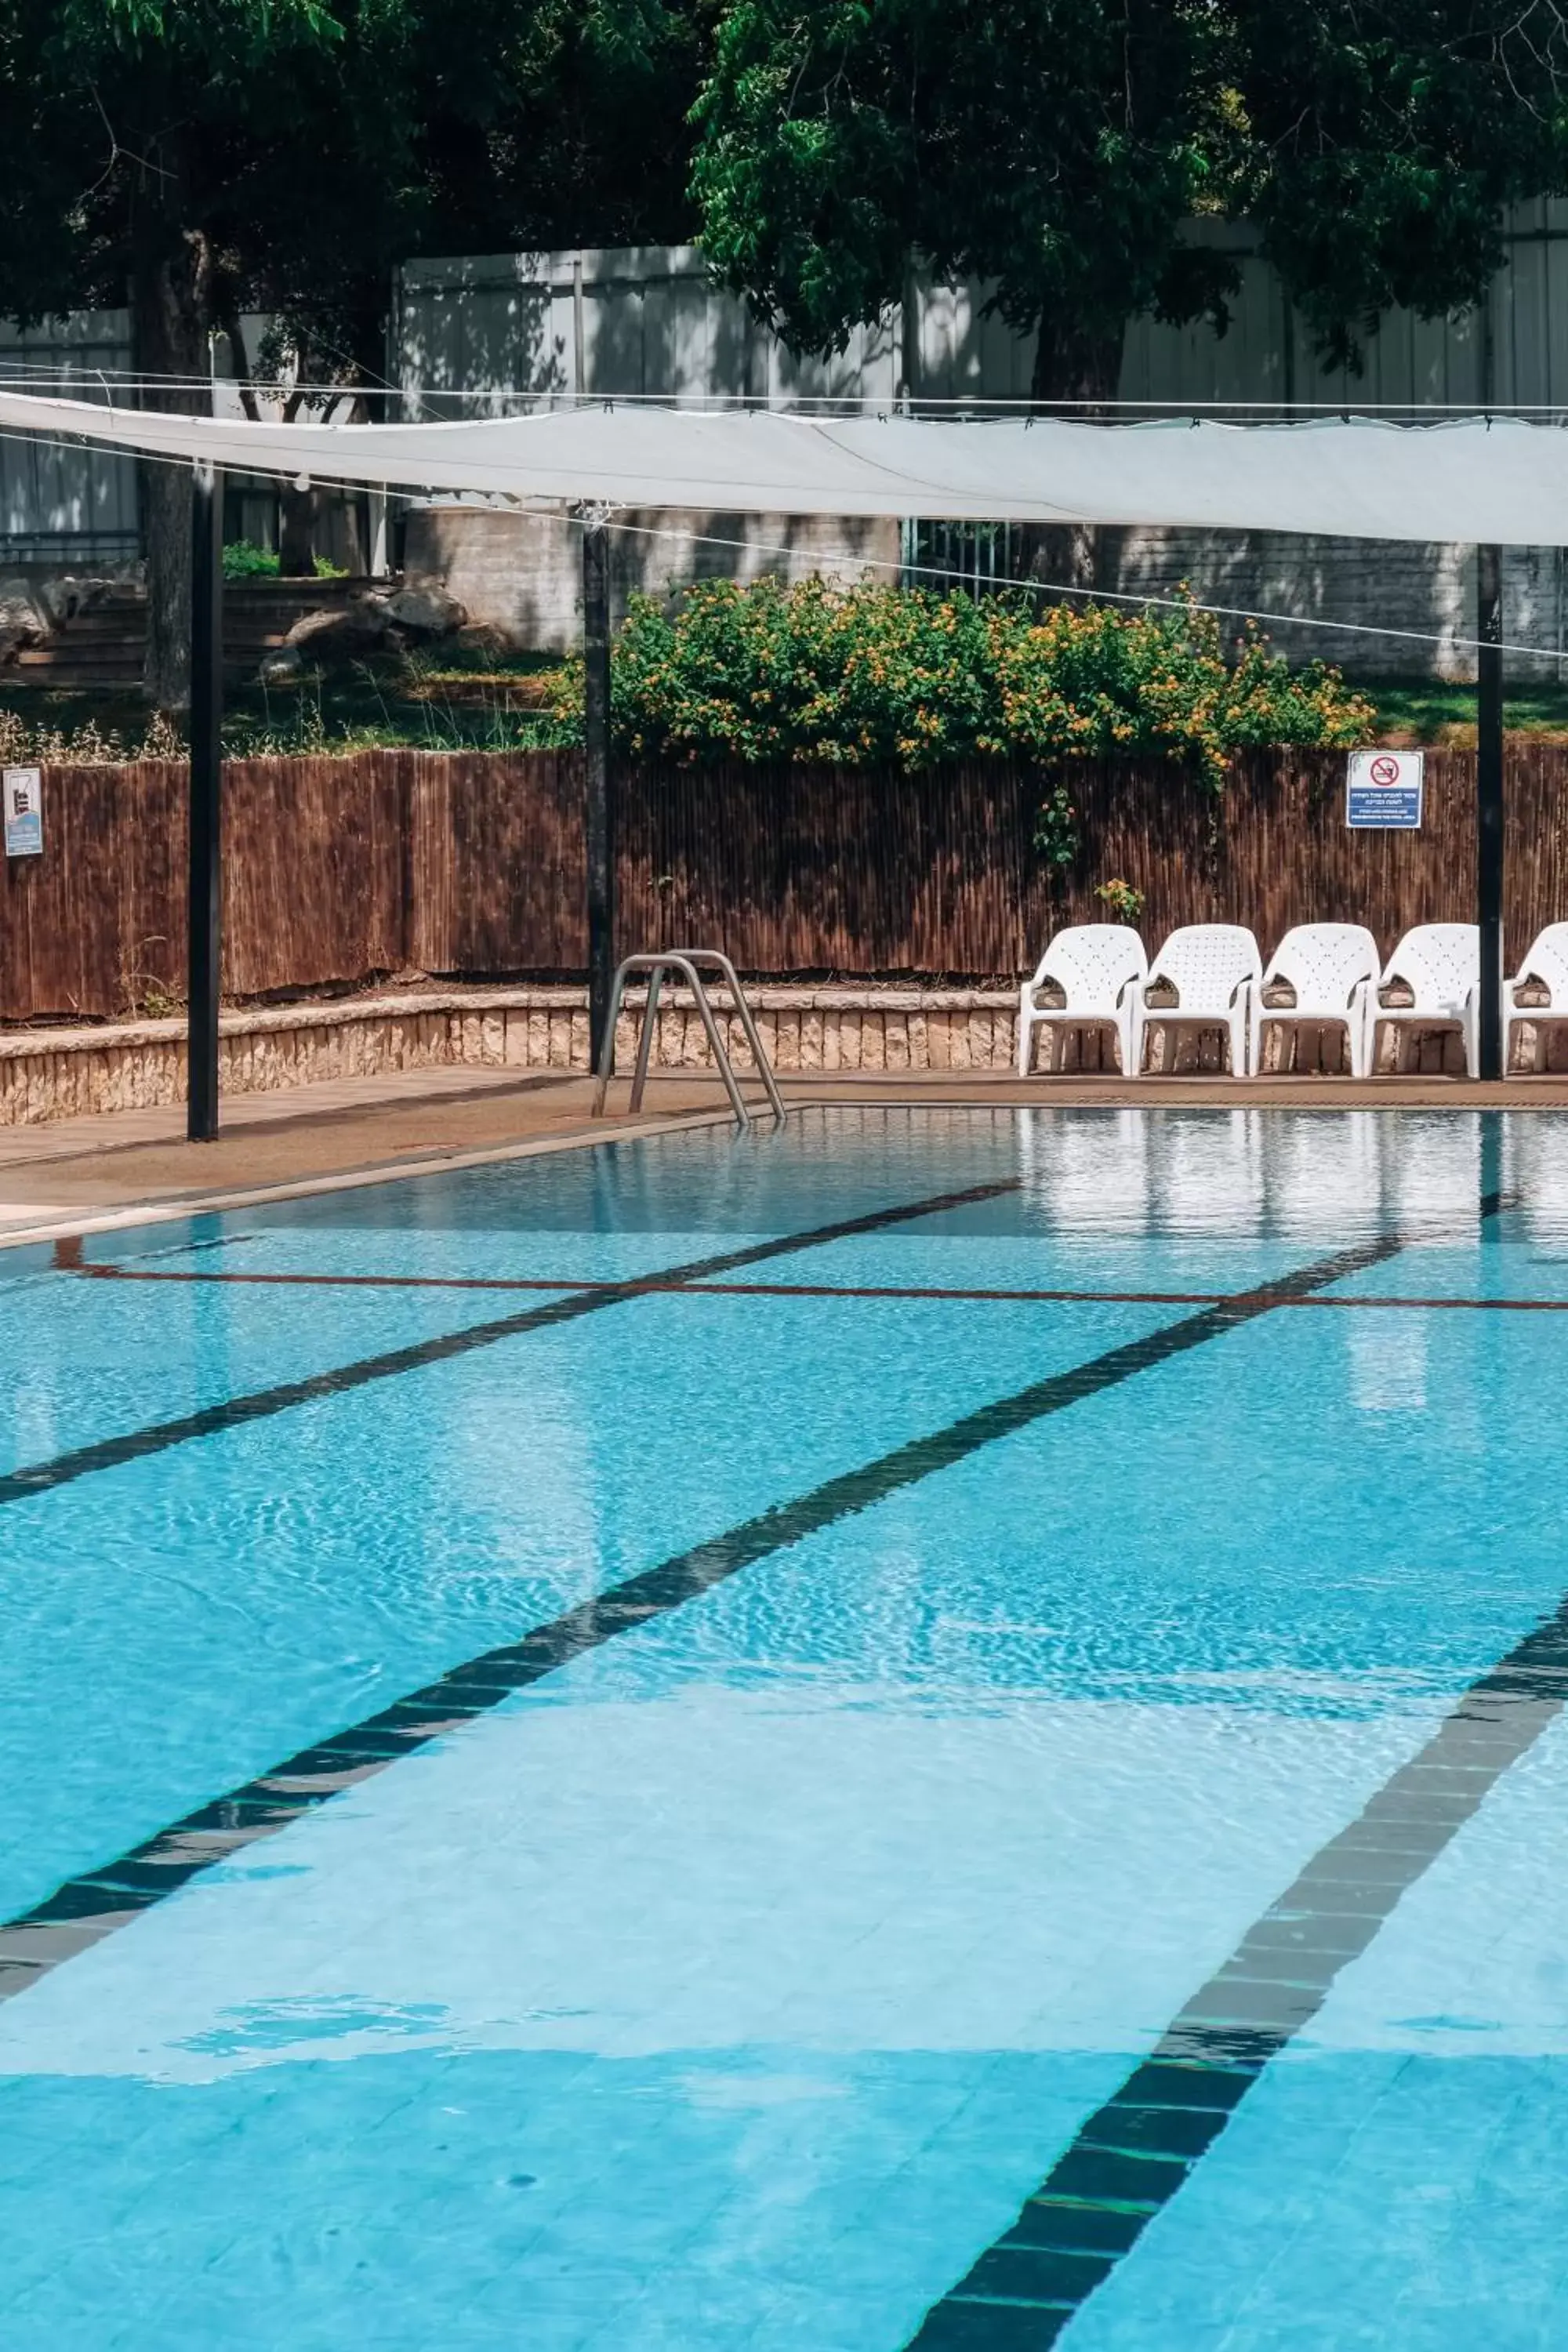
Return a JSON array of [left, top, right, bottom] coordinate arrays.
[[0, 0, 699, 708]]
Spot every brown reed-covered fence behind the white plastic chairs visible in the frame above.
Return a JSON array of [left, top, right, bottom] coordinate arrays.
[[0, 746, 1568, 1021]]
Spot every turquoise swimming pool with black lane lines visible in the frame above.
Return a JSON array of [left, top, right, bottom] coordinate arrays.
[[0, 1110, 1568, 2352]]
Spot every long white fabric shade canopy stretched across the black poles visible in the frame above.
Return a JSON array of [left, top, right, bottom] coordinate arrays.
[[0, 390, 1568, 546]]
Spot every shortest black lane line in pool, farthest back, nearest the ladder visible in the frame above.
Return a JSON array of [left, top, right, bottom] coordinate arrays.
[[0, 1176, 1020, 1503]]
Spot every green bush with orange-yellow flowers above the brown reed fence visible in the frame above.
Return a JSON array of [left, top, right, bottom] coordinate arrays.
[[553, 579, 1375, 788]]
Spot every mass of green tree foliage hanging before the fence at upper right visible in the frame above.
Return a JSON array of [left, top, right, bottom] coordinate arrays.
[[694, 0, 1568, 454]]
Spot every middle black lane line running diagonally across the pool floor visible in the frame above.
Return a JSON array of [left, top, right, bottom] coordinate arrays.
[[0, 1211, 1403, 1999]]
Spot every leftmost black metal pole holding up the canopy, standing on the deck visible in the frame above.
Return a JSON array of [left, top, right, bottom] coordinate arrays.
[[186, 466, 223, 1143]]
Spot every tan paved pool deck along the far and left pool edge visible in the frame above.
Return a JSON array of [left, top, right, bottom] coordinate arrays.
[[0, 1068, 1568, 1247]]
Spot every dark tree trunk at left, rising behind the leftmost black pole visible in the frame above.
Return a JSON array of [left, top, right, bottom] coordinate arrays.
[[132, 216, 212, 710]]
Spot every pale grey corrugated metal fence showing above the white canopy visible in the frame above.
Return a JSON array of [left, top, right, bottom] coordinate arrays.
[[390, 198, 1568, 416]]
